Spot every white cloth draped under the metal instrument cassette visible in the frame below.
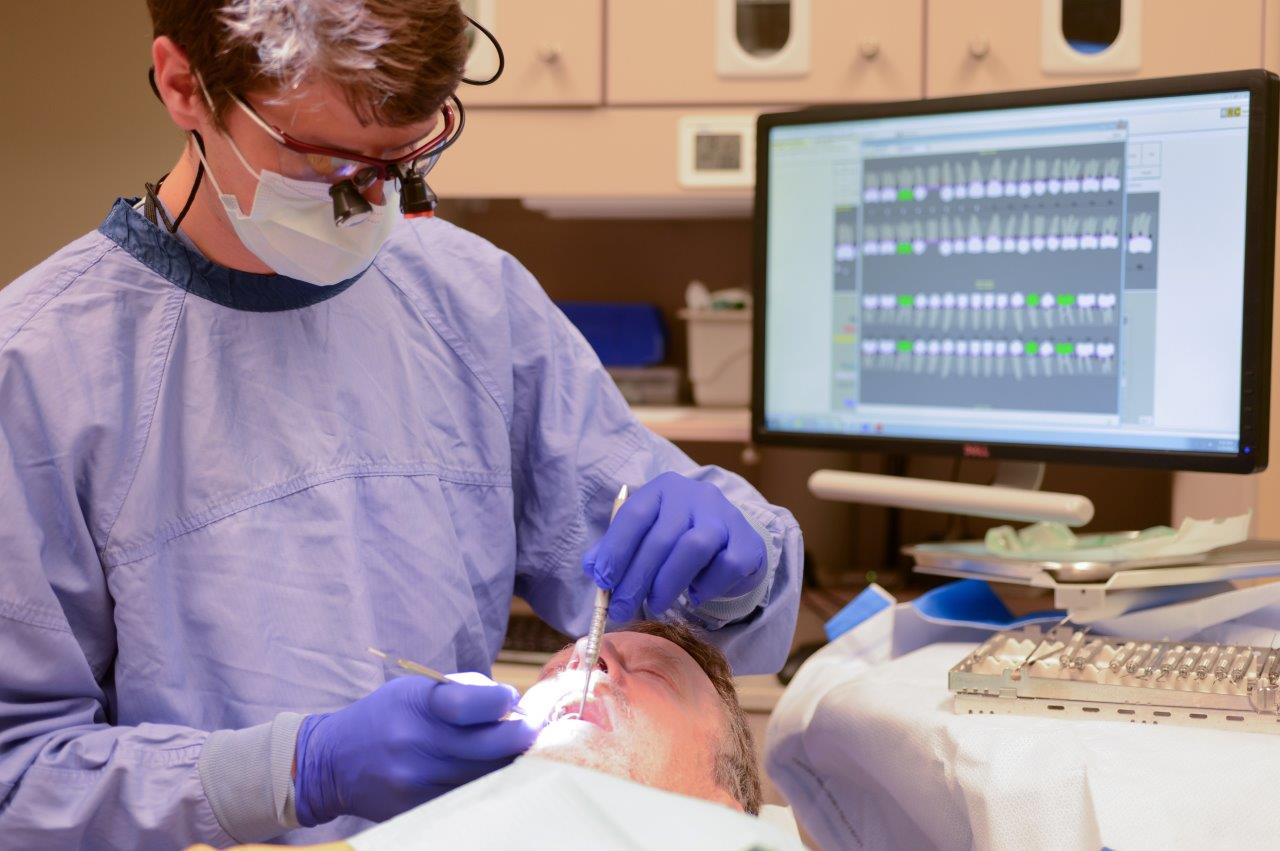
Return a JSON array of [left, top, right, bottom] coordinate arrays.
[[765, 596, 1280, 851]]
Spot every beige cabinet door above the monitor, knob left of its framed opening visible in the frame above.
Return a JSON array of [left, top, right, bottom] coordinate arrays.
[[924, 0, 1263, 97]]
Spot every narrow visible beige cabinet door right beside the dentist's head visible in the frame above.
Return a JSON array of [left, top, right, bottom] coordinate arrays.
[[458, 0, 604, 106]]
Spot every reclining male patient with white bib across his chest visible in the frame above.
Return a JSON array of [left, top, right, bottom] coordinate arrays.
[[197, 621, 803, 851]]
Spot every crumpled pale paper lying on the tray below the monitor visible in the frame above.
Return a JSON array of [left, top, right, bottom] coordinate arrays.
[[986, 512, 1253, 562]]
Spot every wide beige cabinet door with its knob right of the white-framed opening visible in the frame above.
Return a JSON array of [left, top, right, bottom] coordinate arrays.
[[605, 0, 924, 105]]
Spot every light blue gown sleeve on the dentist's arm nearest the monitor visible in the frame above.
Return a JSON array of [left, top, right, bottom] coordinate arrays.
[[504, 257, 803, 673]]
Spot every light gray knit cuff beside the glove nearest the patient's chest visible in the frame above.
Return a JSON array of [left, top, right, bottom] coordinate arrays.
[[200, 713, 303, 842]]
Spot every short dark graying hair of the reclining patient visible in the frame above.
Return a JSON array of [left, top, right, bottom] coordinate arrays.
[[625, 621, 760, 815]]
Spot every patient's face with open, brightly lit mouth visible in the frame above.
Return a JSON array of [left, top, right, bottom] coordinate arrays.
[[520, 632, 737, 806]]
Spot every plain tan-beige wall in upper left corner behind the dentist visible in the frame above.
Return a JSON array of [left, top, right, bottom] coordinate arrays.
[[0, 0, 182, 285]]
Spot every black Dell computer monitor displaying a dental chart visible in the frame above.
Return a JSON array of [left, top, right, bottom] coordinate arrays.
[[753, 70, 1277, 472]]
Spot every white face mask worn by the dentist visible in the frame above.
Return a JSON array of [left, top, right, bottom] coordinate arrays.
[[196, 137, 401, 287]]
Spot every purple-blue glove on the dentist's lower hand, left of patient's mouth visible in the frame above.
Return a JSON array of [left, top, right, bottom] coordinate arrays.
[[293, 673, 538, 827]]
